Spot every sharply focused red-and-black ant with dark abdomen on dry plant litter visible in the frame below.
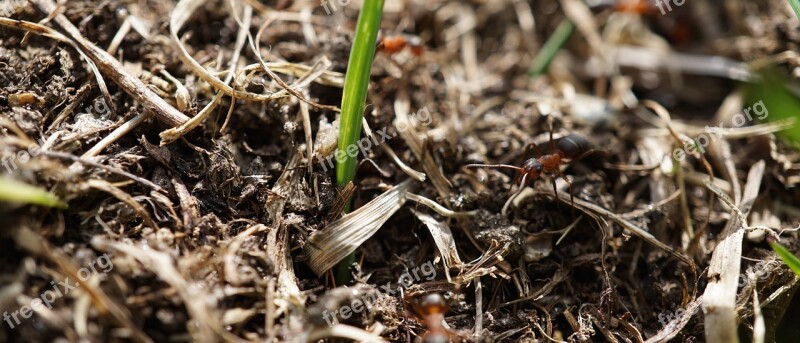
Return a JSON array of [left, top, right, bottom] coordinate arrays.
[[467, 127, 594, 213]]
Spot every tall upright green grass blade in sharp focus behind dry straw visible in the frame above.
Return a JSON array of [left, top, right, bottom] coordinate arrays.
[[336, 0, 383, 284]]
